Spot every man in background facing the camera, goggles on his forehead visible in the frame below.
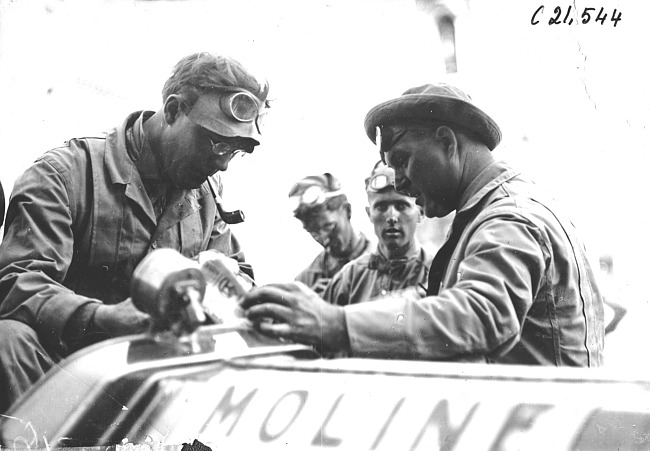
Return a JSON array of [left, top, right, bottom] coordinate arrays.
[[323, 161, 433, 305]]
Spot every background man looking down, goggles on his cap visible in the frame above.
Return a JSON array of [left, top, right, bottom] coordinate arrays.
[[289, 173, 370, 293]]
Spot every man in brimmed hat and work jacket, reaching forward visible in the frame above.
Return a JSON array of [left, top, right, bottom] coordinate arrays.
[[244, 84, 604, 367]]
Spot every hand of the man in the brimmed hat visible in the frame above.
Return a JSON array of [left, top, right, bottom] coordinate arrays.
[[241, 282, 350, 351]]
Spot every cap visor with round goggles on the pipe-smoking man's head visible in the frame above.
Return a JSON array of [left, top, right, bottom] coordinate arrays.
[[187, 86, 268, 143]]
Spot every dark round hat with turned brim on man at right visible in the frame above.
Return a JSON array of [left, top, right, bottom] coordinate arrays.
[[364, 83, 501, 150]]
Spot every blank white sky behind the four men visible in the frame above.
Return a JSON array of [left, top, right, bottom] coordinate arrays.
[[0, 0, 650, 368]]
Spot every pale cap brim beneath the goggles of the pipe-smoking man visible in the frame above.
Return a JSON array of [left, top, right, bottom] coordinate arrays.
[[187, 93, 261, 145]]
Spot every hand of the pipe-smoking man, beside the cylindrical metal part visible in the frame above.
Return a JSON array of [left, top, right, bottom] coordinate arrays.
[[94, 298, 151, 337]]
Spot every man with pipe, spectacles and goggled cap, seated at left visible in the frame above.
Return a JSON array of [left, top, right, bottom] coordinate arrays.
[[0, 53, 268, 411]]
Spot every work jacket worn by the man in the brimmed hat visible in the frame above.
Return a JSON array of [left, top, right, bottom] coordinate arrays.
[[344, 163, 604, 366]]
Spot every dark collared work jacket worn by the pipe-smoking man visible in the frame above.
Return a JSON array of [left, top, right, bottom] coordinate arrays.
[[0, 112, 248, 354]]
